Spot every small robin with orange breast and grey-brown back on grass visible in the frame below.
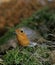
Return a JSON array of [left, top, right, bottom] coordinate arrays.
[[15, 27, 44, 47]]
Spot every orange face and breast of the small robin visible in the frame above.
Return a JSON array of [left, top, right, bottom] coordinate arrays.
[[15, 29, 30, 46]]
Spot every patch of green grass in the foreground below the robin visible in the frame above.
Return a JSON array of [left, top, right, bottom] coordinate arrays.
[[3, 46, 50, 65]]
